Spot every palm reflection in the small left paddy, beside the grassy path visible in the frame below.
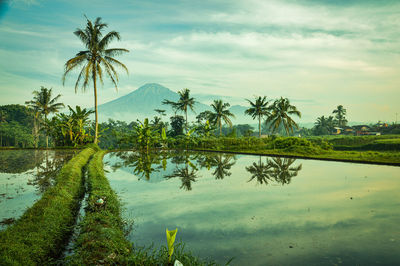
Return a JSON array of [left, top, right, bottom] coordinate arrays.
[[28, 150, 74, 193]]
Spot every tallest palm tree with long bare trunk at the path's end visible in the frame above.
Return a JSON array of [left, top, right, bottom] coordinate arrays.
[[63, 17, 129, 143]]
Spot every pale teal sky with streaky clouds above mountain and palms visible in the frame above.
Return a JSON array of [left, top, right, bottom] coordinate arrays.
[[0, 0, 400, 122]]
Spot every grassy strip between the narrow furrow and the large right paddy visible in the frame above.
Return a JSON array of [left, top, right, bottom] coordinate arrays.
[[68, 151, 131, 265]]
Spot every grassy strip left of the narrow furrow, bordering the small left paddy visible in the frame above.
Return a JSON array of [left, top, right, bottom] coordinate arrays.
[[0, 148, 95, 265]]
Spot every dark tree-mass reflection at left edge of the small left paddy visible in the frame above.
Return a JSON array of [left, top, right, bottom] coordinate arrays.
[[0, 150, 44, 174]]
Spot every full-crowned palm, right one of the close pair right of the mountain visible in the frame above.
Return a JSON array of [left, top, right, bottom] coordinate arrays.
[[266, 97, 301, 135]]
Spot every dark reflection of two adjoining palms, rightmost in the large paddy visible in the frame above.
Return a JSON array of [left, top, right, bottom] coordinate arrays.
[[246, 156, 302, 185]]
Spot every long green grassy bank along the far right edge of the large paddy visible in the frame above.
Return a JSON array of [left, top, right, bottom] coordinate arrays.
[[171, 136, 400, 165]]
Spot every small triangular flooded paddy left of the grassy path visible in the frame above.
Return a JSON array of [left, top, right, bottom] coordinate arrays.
[[0, 150, 74, 230]]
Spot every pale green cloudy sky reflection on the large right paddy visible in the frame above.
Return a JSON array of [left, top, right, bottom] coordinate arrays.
[[105, 154, 400, 265]]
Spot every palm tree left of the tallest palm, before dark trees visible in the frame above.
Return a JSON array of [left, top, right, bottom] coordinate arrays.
[[25, 86, 64, 148]]
